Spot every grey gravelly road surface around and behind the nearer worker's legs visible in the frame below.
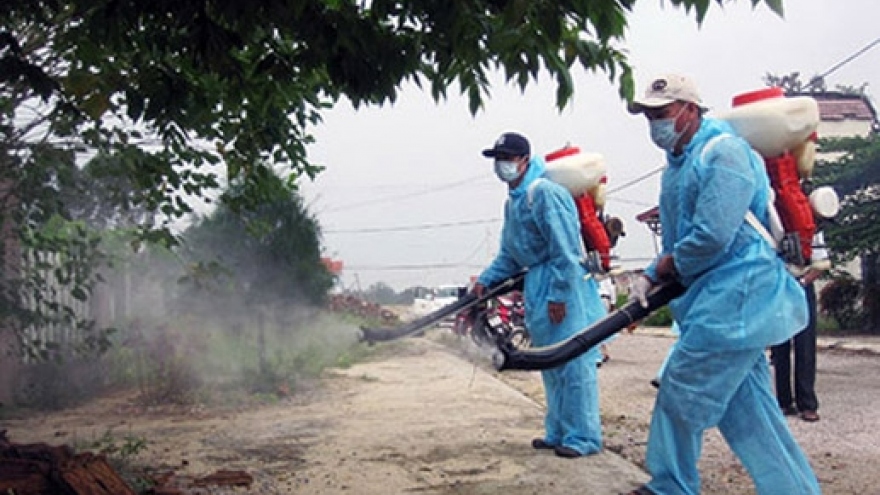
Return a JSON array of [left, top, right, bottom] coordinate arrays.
[[532, 330, 880, 495]]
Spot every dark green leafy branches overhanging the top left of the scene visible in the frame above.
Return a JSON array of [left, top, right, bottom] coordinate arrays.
[[0, 0, 782, 348]]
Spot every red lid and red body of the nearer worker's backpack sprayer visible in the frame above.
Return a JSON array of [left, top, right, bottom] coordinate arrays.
[[733, 87, 816, 263]]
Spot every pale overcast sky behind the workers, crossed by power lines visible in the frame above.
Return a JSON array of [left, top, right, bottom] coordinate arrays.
[[301, 0, 880, 290]]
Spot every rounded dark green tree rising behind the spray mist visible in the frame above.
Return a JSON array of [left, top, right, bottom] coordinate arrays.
[[181, 175, 333, 313]]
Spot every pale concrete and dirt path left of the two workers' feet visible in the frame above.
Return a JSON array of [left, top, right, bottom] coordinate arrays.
[[4, 340, 645, 495]]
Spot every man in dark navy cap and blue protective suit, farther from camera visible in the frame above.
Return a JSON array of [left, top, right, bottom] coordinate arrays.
[[474, 132, 605, 458]]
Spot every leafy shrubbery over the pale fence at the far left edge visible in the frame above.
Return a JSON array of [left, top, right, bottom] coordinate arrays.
[[0, 145, 115, 359]]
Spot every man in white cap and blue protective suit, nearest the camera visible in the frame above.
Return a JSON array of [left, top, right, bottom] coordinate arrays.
[[629, 75, 821, 495]]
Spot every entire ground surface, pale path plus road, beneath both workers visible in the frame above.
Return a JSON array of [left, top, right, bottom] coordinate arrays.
[[0, 329, 880, 495]]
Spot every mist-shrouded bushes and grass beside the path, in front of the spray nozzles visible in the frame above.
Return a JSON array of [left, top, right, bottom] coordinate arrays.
[[0, 176, 368, 411]]
